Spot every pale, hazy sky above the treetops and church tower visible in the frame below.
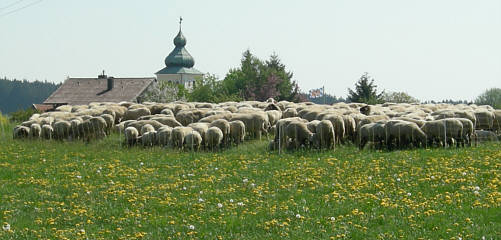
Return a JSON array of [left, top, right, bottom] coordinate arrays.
[[0, 0, 501, 101]]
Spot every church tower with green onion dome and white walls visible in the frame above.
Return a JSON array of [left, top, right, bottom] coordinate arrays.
[[155, 18, 203, 89]]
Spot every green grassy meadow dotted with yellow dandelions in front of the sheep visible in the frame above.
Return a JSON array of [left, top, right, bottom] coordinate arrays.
[[0, 123, 501, 239]]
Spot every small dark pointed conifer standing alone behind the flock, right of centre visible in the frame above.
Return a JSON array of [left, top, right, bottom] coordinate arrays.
[[347, 73, 384, 104]]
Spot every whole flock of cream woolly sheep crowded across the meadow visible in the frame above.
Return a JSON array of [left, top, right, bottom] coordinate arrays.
[[13, 99, 501, 150]]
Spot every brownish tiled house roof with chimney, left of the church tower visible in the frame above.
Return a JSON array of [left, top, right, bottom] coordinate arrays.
[[43, 78, 155, 105]]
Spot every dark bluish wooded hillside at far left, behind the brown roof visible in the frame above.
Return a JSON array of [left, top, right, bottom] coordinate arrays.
[[0, 78, 60, 114]]
